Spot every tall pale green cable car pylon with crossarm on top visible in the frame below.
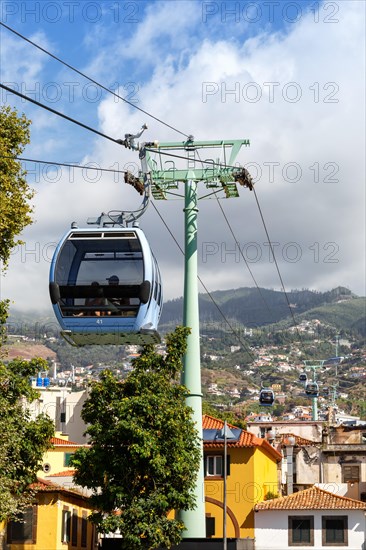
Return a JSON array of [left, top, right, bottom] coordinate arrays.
[[139, 136, 253, 538]]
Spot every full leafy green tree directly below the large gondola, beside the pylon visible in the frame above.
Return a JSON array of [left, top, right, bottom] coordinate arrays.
[[72, 327, 200, 550]]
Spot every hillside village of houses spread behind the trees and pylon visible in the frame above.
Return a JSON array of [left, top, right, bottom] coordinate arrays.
[[1, 292, 366, 550]]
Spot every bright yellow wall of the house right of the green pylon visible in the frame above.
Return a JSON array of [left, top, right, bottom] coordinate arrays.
[[205, 448, 277, 538]]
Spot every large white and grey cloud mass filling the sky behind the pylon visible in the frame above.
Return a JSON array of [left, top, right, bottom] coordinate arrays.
[[4, 2, 365, 314]]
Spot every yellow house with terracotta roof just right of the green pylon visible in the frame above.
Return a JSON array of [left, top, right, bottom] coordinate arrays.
[[202, 415, 282, 538]]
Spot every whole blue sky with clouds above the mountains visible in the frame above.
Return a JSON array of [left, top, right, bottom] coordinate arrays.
[[0, 0, 366, 311]]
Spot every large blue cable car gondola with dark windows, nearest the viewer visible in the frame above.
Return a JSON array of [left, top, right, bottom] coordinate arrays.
[[49, 224, 163, 346]]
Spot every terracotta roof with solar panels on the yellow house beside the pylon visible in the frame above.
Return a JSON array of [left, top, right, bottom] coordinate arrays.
[[202, 414, 282, 461]]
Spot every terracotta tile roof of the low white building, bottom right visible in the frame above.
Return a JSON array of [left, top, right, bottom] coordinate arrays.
[[254, 486, 366, 511]]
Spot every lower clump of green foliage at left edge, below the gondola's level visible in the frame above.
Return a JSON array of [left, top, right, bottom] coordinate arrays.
[[0, 358, 54, 521]]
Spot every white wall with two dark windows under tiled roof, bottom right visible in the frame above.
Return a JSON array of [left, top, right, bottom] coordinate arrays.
[[254, 510, 366, 550]]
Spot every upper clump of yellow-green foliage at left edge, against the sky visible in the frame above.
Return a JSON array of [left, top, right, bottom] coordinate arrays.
[[0, 106, 34, 267]]
